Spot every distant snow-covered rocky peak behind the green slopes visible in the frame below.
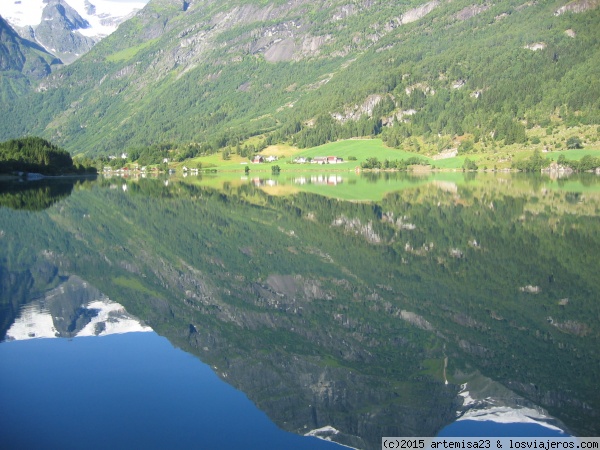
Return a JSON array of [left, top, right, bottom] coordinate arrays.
[[0, 0, 146, 64]]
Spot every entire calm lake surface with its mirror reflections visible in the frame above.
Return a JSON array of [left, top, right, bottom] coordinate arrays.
[[0, 173, 600, 449]]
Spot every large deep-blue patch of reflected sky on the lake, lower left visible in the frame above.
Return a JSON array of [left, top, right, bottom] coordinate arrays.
[[0, 333, 342, 449]]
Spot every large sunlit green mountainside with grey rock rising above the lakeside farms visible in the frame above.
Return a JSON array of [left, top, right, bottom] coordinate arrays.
[[0, 0, 600, 159]]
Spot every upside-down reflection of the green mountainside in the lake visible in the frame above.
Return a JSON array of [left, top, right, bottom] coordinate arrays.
[[0, 175, 600, 448]]
